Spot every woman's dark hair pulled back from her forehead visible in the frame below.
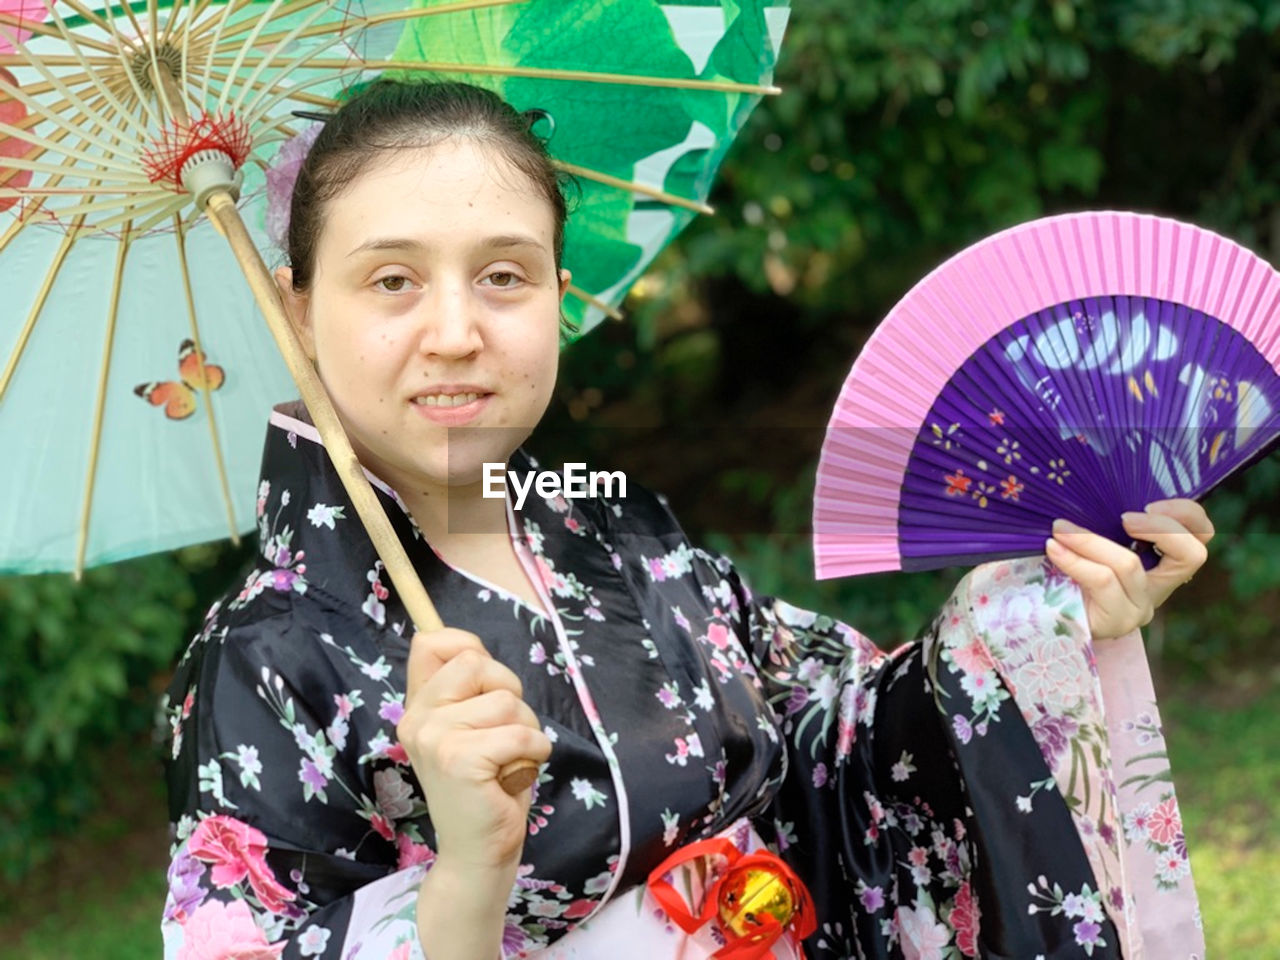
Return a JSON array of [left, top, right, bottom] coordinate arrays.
[[293, 79, 568, 293]]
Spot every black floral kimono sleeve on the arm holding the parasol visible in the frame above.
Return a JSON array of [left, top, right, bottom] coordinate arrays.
[[161, 616, 434, 960]]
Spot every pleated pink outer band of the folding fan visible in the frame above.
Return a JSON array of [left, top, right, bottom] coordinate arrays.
[[813, 211, 1280, 580]]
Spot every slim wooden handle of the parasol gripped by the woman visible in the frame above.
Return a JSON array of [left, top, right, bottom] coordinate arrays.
[[205, 191, 538, 796]]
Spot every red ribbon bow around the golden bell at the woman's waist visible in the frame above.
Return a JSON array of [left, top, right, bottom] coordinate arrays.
[[649, 837, 818, 960]]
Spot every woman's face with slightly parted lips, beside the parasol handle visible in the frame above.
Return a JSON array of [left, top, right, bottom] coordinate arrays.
[[284, 140, 568, 497]]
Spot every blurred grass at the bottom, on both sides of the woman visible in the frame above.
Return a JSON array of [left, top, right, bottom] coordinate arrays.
[[0, 675, 1280, 960]]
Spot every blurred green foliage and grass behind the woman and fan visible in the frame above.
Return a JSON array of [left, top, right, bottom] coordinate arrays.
[[0, 0, 1280, 960]]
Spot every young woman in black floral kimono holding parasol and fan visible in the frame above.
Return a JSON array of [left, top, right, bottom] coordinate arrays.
[[164, 82, 1212, 960]]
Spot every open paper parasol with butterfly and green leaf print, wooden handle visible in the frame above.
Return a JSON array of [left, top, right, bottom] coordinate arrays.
[[0, 0, 786, 788]]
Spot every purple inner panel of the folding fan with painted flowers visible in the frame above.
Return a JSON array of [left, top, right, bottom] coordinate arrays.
[[899, 297, 1280, 570]]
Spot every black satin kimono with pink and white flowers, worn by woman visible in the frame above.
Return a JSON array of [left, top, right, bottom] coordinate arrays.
[[163, 408, 1203, 960]]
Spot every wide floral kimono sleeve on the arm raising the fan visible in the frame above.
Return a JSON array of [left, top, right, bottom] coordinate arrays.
[[691, 545, 1198, 957]]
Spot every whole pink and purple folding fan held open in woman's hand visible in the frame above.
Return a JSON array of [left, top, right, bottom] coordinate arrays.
[[814, 212, 1280, 579]]
